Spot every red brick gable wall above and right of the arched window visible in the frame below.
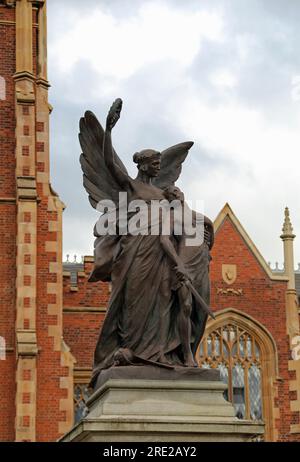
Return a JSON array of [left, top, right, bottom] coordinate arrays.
[[211, 218, 300, 441]]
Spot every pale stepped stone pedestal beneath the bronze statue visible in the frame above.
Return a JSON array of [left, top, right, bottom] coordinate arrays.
[[61, 367, 264, 442]]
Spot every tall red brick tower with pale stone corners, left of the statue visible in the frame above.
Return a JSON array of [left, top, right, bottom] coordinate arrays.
[[0, 0, 73, 441]]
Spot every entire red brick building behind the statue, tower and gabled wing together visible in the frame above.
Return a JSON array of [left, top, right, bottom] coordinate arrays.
[[0, 0, 300, 441]]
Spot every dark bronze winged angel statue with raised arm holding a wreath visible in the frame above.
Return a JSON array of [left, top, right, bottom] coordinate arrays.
[[79, 99, 213, 387]]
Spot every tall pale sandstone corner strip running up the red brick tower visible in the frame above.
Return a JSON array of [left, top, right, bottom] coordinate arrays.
[[14, 0, 38, 441]]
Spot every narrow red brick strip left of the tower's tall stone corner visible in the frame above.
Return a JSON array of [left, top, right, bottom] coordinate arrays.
[[0, 5, 16, 441]]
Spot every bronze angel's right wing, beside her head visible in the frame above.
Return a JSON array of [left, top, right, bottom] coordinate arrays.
[[152, 141, 194, 189]]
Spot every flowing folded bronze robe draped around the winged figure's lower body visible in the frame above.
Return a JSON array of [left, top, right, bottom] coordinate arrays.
[[90, 202, 210, 385]]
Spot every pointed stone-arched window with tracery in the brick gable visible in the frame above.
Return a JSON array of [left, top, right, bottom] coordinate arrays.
[[197, 308, 278, 441]]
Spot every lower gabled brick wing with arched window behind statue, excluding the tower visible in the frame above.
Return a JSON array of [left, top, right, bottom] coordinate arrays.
[[63, 204, 300, 441]]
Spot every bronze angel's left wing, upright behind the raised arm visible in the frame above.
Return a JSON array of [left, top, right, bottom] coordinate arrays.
[[79, 111, 128, 208]]
